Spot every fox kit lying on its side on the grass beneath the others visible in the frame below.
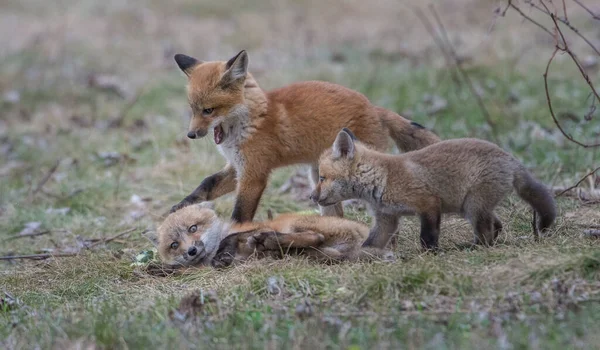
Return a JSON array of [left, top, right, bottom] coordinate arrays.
[[147, 204, 393, 267]]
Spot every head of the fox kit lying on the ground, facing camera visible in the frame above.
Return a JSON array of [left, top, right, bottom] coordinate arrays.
[[147, 204, 226, 266]]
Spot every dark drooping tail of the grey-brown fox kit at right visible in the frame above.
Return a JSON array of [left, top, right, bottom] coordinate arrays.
[[513, 166, 556, 236]]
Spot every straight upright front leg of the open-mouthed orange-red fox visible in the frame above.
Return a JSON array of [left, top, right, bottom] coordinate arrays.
[[231, 174, 269, 223]]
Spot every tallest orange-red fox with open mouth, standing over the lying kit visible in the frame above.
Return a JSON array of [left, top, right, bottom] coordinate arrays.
[[171, 51, 439, 223]]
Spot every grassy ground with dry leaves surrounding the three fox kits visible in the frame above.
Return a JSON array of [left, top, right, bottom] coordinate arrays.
[[0, 0, 600, 349]]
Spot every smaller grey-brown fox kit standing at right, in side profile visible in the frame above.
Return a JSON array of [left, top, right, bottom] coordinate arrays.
[[311, 129, 556, 249]]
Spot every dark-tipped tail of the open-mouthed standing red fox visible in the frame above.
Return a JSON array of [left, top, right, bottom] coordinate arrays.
[[376, 107, 440, 152]]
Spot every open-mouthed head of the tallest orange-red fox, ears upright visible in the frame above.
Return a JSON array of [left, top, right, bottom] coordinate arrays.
[[175, 50, 248, 144]]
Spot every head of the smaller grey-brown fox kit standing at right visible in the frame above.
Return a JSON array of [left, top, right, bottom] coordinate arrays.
[[310, 128, 360, 206]]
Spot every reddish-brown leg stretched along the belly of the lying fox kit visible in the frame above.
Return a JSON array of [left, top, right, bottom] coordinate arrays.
[[249, 231, 325, 250]]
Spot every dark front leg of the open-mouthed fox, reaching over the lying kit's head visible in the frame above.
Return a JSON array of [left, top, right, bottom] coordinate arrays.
[[171, 164, 237, 213]]
